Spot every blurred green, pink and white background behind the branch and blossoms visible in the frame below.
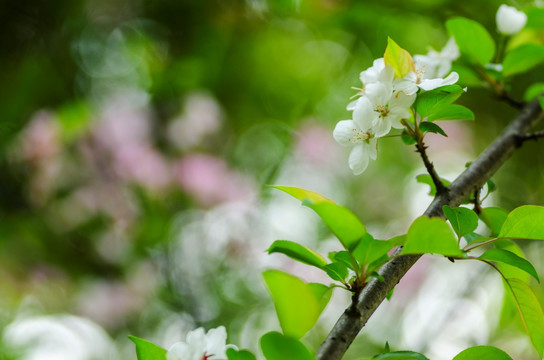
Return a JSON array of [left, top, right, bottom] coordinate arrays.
[[0, 0, 544, 360]]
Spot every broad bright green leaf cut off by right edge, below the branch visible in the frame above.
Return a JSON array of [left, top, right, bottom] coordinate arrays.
[[499, 205, 544, 240]]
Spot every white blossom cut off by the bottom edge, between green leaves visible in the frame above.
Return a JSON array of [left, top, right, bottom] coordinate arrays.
[[166, 326, 231, 360]]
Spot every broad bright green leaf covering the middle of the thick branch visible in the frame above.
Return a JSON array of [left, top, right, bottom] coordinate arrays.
[[402, 216, 464, 256]]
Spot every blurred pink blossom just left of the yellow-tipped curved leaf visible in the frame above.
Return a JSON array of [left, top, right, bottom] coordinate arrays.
[[173, 154, 256, 207]]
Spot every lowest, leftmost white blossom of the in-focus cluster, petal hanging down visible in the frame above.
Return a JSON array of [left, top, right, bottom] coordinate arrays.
[[333, 120, 378, 175]]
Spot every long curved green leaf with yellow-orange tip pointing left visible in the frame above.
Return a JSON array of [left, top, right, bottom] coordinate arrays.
[[273, 186, 366, 250]]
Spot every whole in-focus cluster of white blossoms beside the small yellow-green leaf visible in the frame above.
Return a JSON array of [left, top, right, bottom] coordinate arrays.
[[333, 38, 459, 175]]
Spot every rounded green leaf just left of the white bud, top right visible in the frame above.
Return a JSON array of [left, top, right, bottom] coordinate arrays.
[[446, 17, 495, 65]]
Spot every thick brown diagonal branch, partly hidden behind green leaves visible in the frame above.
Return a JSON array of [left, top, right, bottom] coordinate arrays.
[[316, 96, 542, 360]]
